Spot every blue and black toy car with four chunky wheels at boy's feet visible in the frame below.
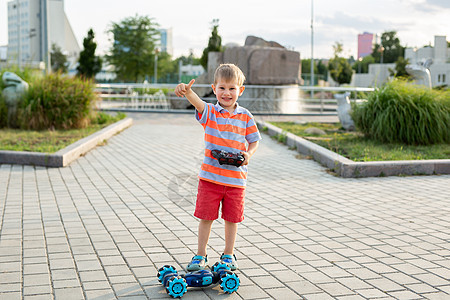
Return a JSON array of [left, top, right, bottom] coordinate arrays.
[[157, 262, 240, 298]]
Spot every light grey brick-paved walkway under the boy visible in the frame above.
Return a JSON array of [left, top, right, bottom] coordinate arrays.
[[0, 114, 450, 300]]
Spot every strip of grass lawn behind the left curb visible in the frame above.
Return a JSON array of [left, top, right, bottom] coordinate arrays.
[[0, 114, 125, 153]]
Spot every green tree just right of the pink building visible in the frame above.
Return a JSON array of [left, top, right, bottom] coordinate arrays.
[[372, 31, 405, 63]]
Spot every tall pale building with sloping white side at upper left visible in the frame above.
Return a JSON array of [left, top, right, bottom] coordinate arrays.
[[8, 0, 80, 68]]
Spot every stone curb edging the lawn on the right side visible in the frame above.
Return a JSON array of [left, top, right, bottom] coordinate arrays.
[[256, 121, 450, 178]]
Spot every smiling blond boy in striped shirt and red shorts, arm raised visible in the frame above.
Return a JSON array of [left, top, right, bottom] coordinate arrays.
[[175, 64, 261, 271]]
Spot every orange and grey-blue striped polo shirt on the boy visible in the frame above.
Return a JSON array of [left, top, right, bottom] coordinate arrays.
[[195, 102, 261, 188]]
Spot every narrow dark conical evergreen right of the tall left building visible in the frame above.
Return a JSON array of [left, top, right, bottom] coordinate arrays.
[[77, 28, 102, 78]]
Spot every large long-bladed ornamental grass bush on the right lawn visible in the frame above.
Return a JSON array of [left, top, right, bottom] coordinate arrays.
[[352, 80, 450, 145]]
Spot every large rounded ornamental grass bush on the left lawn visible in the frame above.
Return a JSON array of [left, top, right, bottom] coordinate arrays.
[[18, 73, 96, 130]]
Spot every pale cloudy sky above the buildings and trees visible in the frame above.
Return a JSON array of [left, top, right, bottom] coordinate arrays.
[[0, 0, 450, 58]]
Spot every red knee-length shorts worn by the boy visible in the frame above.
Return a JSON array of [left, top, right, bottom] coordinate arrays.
[[194, 179, 245, 223]]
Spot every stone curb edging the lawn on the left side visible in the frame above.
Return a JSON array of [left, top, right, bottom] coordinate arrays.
[[0, 118, 133, 168]]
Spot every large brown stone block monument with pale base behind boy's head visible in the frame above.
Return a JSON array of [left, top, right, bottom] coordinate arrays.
[[190, 36, 302, 113]]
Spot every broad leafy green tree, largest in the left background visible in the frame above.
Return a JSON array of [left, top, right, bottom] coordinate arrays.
[[106, 15, 160, 82]]
